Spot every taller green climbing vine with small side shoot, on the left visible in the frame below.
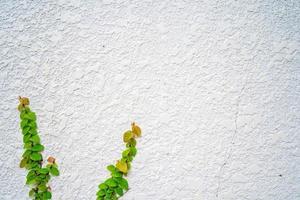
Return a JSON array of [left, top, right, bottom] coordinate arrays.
[[18, 97, 59, 200]]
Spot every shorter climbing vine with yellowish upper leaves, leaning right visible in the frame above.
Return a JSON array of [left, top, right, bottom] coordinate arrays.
[[97, 123, 141, 200]]
